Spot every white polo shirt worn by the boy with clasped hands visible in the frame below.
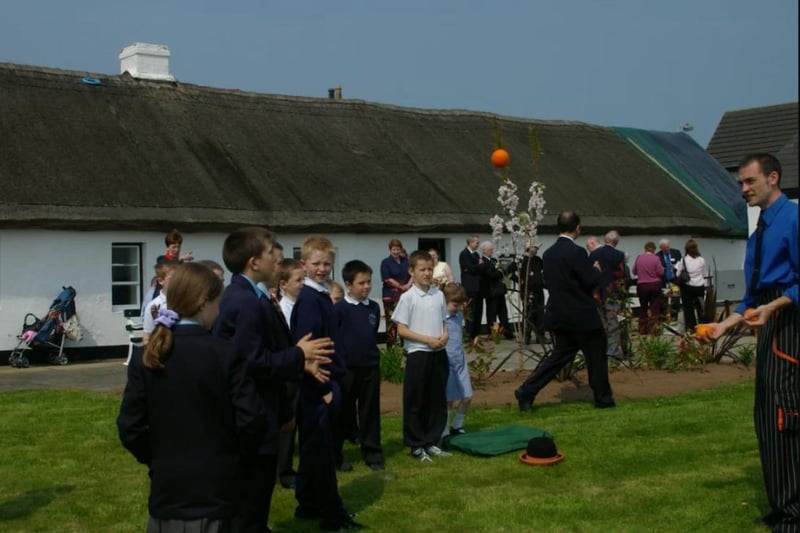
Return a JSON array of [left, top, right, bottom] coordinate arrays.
[[392, 285, 447, 352]]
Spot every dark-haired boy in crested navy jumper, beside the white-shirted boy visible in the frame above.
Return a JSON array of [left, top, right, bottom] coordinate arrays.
[[333, 259, 384, 470]]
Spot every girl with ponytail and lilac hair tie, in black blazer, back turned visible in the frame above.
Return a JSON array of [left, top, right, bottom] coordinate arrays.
[[117, 263, 265, 531]]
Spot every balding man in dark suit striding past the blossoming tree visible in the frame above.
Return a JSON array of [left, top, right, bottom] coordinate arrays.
[[514, 211, 615, 411]]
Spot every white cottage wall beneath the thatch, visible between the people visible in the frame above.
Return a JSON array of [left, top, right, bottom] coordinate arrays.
[[0, 230, 745, 351]]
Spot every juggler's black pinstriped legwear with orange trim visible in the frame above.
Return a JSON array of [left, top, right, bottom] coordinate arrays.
[[754, 289, 800, 531]]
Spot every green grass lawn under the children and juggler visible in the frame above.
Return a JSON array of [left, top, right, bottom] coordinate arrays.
[[0, 382, 767, 533]]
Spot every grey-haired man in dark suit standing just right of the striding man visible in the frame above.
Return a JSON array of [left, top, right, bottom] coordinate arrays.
[[589, 230, 625, 357]]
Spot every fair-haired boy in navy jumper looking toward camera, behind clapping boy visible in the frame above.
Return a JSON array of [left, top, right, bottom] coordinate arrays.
[[290, 235, 362, 531]]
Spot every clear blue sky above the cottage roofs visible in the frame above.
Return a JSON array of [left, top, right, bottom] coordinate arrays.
[[0, 0, 798, 146]]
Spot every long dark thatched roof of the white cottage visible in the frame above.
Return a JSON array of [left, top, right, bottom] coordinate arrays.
[[0, 64, 746, 235]]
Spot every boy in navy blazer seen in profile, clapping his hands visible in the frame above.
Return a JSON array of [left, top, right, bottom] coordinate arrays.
[[213, 226, 333, 532]]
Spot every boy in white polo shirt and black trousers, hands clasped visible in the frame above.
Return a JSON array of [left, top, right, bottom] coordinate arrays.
[[392, 250, 451, 463]]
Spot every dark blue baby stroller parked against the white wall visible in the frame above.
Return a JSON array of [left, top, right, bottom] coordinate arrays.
[[8, 287, 83, 368]]
